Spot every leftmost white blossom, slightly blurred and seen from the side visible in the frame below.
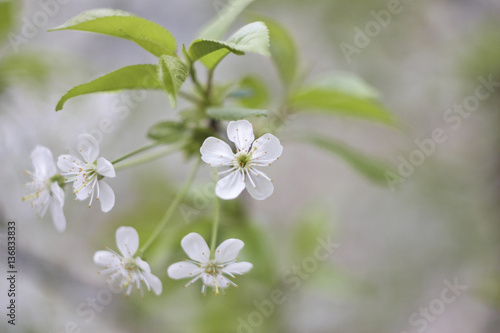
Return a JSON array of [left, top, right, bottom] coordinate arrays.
[[23, 146, 66, 232]]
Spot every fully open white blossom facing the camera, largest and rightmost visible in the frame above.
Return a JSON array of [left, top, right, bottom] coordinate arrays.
[[200, 120, 283, 200]]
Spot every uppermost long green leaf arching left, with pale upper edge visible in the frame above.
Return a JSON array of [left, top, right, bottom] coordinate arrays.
[[49, 9, 177, 57]]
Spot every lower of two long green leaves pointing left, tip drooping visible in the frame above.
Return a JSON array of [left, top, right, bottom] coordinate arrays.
[[56, 65, 160, 111]]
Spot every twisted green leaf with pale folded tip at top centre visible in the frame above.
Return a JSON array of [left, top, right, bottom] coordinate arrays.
[[189, 22, 269, 70]]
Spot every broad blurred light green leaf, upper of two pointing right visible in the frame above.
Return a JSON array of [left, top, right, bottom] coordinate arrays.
[[290, 81, 396, 125]]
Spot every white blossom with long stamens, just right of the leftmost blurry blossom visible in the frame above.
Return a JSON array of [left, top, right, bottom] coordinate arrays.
[[57, 134, 116, 212]]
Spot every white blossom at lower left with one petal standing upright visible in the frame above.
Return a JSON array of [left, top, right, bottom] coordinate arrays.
[[94, 227, 162, 296]]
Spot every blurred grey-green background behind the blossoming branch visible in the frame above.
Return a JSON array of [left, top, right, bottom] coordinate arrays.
[[0, 0, 500, 333]]
